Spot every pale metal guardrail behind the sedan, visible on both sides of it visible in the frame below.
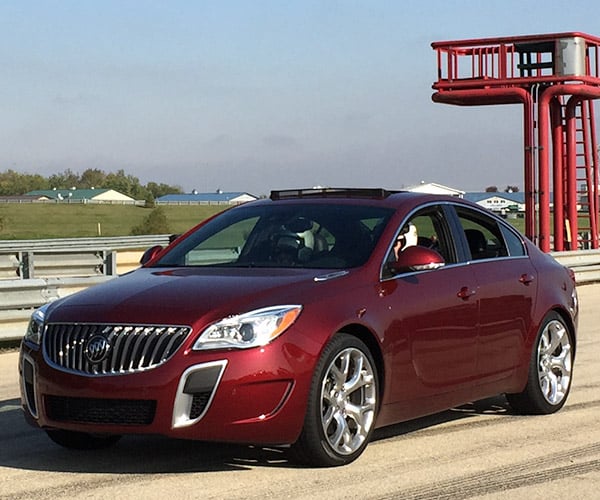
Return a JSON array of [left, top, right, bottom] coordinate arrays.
[[0, 234, 600, 341]]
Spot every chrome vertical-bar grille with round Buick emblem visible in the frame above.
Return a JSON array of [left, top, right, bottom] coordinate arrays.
[[43, 323, 191, 375]]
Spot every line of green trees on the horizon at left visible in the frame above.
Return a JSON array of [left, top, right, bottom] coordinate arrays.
[[0, 168, 183, 201]]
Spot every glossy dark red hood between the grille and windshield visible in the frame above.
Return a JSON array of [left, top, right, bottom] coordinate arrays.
[[46, 268, 352, 325]]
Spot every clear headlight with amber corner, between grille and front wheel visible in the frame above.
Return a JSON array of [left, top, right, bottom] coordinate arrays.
[[193, 305, 302, 350]]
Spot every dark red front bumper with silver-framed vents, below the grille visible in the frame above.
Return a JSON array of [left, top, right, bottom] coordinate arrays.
[[19, 343, 314, 444]]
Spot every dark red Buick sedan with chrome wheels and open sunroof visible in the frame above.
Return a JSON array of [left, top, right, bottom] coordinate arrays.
[[20, 189, 578, 466]]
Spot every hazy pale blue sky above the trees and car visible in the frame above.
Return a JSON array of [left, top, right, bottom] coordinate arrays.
[[0, 0, 600, 195]]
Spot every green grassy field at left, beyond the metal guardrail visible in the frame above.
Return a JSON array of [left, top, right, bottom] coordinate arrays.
[[0, 203, 227, 240]]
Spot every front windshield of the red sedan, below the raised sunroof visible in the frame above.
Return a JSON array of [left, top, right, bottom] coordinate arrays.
[[154, 204, 393, 269]]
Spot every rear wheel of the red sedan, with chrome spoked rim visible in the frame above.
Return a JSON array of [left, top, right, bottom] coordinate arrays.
[[506, 312, 575, 415]]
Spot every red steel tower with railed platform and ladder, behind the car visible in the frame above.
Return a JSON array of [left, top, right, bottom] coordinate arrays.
[[432, 32, 600, 252]]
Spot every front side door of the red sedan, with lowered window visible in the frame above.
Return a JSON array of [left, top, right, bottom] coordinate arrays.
[[380, 205, 478, 401]]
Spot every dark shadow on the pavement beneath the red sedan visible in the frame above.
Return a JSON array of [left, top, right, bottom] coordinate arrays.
[[0, 398, 509, 474]]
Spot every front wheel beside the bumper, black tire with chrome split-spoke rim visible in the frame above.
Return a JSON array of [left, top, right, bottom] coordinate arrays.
[[292, 333, 379, 467]]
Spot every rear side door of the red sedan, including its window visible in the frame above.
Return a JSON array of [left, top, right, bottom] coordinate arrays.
[[456, 207, 537, 378]]
